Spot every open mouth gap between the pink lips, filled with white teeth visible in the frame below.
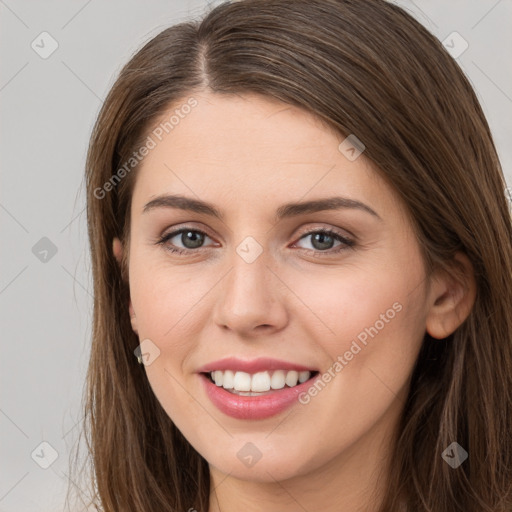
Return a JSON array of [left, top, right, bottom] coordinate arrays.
[[202, 370, 318, 396]]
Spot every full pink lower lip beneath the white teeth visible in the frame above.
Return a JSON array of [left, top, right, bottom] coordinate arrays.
[[199, 374, 319, 420]]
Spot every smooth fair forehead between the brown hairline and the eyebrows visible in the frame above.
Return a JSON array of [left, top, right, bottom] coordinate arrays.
[[133, 93, 398, 219]]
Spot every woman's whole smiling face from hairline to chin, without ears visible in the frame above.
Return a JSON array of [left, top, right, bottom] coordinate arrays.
[[121, 93, 428, 482]]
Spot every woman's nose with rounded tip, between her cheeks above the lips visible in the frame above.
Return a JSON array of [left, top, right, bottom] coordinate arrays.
[[213, 246, 288, 338]]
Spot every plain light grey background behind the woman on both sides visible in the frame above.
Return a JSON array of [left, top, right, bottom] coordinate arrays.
[[0, 0, 512, 512]]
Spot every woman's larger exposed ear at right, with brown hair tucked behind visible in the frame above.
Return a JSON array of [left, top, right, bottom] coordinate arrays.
[[426, 252, 476, 339]]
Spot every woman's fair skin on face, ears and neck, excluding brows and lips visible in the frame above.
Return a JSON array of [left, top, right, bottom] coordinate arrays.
[[113, 91, 475, 512]]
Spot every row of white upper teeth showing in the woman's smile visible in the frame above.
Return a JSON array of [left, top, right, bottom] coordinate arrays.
[[210, 370, 311, 392]]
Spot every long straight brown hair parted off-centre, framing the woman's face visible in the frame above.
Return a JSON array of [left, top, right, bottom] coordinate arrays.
[[69, 0, 512, 512]]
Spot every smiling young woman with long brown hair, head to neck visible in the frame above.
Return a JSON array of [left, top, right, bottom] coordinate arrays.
[[71, 0, 512, 512]]
